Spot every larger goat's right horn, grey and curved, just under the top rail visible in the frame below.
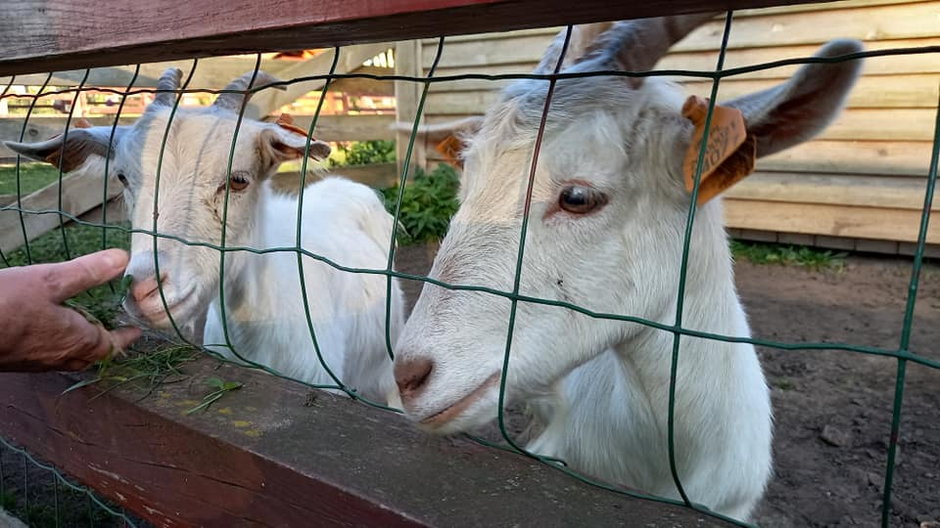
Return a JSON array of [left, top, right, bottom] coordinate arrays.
[[591, 12, 717, 79]]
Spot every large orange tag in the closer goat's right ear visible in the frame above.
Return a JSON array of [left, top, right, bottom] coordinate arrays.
[[682, 95, 757, 205]]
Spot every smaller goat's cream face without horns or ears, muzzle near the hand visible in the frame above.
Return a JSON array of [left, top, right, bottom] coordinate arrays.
[[113, 109, 275, 327]]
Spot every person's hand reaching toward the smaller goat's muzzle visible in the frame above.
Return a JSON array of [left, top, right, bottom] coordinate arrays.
[[0, 249, 140, 371]]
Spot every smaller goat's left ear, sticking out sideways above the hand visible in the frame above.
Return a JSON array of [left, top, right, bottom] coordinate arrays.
[[3, 126, 127, 172]]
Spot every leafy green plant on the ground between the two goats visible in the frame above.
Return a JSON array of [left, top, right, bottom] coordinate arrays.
[[382, 164, 460, 245]]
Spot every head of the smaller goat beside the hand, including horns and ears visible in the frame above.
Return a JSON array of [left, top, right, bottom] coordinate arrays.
[[4, 69, 329, 328]]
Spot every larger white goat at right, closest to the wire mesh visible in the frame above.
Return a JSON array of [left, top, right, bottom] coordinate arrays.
[[395, 15, 859, 519]]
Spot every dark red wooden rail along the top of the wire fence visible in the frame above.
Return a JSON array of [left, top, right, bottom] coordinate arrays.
[[0, 0, 840, 75]]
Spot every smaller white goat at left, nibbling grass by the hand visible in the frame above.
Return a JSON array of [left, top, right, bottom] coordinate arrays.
[[7, 69, 404, 399]]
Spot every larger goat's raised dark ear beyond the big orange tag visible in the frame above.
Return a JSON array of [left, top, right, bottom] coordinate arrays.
[[723, 40, 862, 157]]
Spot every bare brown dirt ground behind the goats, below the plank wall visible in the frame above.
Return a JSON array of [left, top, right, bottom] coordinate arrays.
[[398, 248, 940, 528]]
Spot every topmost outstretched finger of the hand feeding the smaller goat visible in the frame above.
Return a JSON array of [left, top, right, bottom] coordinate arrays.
[[42, 249, 129, 303]]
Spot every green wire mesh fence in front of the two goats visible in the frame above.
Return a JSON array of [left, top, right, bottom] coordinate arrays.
[[0, 8, 940, 526]]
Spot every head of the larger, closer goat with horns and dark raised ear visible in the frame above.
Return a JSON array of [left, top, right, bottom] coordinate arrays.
[[396, 16, 859, 433]]
